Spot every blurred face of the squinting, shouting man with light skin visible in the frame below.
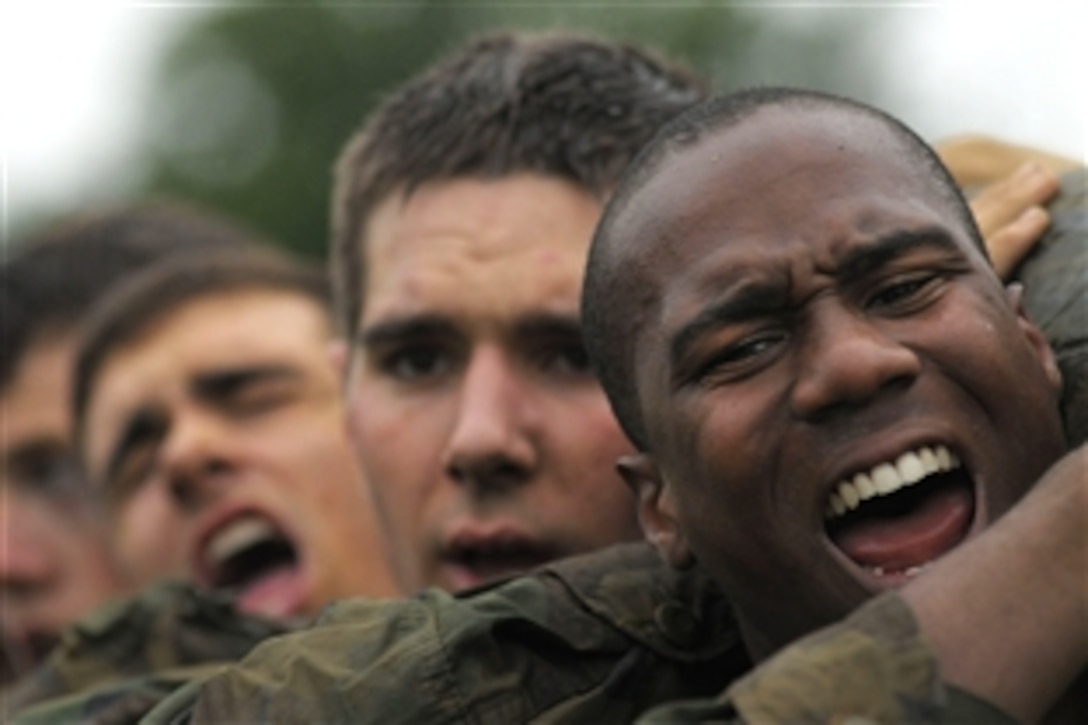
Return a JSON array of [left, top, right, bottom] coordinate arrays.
[[84, 290, 391, 616]]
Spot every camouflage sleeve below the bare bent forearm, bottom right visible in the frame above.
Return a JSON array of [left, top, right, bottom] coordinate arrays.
[[639, 593, 1014, 725]]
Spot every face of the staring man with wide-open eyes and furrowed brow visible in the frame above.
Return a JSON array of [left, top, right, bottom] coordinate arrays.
[[348, 175, 638, 591]]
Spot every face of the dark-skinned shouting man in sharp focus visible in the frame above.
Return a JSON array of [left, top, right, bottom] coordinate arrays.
[[615, 108, 1064, 654]]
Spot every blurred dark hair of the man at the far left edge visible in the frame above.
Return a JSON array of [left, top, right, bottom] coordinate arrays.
[[0, 201, 257, 391]]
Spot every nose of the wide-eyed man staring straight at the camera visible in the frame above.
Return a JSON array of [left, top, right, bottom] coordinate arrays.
[[444, 346, 537, 492]]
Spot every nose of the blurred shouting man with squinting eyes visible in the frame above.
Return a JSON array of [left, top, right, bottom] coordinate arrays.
[[160, 410, 237, 513]]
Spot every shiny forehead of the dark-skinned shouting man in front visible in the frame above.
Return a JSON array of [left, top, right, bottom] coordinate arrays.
[[609, 106, 954, 290]]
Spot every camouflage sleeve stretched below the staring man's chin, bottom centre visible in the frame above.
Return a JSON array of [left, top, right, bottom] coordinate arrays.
[[143, 543, 751, 724]]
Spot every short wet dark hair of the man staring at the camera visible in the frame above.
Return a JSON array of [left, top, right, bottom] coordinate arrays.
[[331, 33, 706, 335]]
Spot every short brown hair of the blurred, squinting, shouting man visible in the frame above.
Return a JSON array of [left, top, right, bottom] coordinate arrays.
[[72, 247, 332, 446]]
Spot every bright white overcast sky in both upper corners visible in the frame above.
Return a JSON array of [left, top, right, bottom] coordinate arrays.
[[0, 0, 1088, 238]]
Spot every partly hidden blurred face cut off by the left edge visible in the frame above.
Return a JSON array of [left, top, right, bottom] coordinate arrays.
[[0, 336, 120, 685]]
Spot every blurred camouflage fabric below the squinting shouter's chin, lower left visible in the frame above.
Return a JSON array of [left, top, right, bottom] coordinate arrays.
[[0, 581, 293, 723]]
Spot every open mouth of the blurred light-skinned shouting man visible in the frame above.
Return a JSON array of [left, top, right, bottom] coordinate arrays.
[[201, 514, 302, 616]]
